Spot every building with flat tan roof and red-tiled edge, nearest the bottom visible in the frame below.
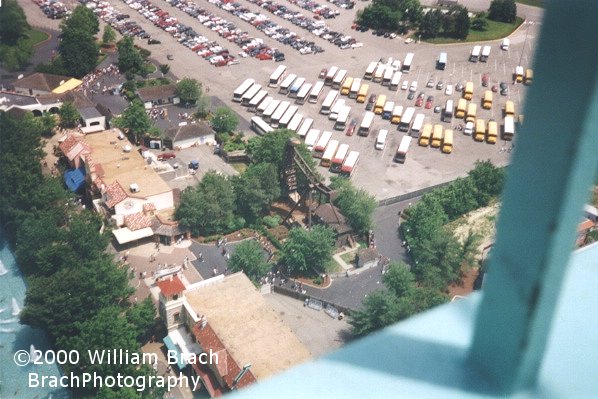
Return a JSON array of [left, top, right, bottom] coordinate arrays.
[[156, 273, 311, 397]]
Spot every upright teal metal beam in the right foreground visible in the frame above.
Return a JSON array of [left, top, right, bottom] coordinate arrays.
[[469, 0, 598, 394]]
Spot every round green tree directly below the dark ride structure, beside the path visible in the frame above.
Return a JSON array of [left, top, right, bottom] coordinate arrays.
[[280, 225, 334, 276]]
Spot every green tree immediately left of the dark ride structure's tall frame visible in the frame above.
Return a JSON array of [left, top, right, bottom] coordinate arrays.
[[233, 163, 280, 223]]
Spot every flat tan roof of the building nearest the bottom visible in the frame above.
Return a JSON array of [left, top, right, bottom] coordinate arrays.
[[185, 273, 311, 380]]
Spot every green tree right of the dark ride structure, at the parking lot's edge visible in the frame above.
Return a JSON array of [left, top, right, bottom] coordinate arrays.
[[334, 183, 378, 235]]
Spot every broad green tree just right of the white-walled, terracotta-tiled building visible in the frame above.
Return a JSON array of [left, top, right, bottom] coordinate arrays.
[[176, 171, 243, 235]]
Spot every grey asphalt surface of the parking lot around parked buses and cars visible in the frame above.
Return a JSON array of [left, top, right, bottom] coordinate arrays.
[[19, 0, 540, 199]]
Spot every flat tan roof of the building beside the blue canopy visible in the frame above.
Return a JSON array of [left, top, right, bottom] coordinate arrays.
[[85, 129, 171, 200]]
